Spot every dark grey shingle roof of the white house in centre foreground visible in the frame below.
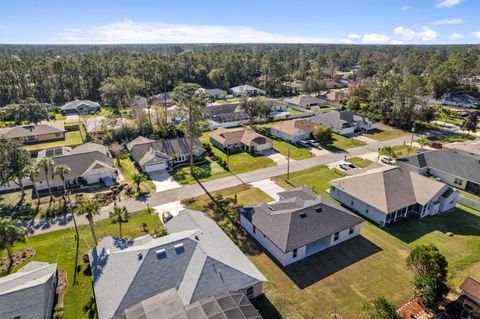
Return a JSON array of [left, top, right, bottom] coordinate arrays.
[[241, 186, 363, 253]]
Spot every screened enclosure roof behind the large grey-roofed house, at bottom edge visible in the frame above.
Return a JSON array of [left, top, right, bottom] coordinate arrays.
[[113, 288, 262, 319]]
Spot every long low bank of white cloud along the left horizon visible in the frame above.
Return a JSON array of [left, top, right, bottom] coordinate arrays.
[[56, 19, 338, 44]]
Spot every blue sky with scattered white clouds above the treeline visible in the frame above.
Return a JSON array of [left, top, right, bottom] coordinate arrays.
[[0, 0, 480, 44]]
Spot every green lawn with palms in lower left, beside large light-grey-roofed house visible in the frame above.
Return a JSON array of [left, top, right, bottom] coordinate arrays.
[[1, 210, 162, 319]]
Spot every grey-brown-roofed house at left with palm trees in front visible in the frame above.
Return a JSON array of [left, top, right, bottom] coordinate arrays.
[[35, 143, 117, 190]]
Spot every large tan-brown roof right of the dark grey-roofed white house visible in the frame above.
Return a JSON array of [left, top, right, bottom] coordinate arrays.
[[329, 167, 446, 214]]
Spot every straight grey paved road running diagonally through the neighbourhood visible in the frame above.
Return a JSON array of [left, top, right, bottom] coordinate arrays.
[[29, 136, 411, 234]]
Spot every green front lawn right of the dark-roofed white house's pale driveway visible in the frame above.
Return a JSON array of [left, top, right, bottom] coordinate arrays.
[[273, 165, 346, 195]]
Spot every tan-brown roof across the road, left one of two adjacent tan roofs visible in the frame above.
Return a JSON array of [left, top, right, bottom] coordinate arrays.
[[209, 127, 272, 146]]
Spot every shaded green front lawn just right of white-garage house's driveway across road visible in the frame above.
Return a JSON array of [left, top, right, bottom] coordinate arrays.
[[170, 160, 231, 184]]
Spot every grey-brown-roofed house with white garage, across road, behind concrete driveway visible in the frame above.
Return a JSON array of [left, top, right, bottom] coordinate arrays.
[[127, 136, 205, 172]]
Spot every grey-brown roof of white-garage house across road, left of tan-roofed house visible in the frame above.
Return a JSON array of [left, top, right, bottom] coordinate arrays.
[[127, 137, 203, 165]]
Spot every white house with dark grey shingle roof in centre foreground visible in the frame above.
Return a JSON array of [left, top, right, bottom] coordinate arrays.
[[240, 187, 363, 266]]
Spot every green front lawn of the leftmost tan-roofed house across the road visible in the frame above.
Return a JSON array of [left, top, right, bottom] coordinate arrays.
[[200, 132, 275, 174]]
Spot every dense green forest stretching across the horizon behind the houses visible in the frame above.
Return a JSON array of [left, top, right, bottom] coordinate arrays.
[[0, 44, 480, 126]]
